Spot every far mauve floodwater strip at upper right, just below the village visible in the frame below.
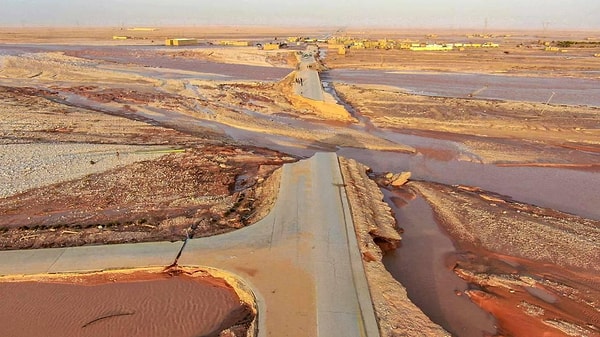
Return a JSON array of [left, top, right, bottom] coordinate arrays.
[[322, 69, 600, 106]]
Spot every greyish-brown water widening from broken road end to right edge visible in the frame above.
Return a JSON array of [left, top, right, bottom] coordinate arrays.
[[338, 145, 600, 220]]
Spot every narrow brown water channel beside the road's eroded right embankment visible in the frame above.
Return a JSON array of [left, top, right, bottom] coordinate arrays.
[[383, 190, 496, 337]]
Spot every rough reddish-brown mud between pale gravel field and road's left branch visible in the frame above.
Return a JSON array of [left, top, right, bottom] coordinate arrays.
[[0, 146, 290, 249]]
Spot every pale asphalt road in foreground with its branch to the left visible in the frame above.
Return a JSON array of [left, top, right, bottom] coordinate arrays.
[[0, 153, 379, 337]]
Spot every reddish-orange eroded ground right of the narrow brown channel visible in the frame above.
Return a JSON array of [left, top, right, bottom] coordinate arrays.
[[408, 182, 600, 336]]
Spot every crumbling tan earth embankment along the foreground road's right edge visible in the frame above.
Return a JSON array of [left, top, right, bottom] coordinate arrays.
[[339, 157, 450, 336]]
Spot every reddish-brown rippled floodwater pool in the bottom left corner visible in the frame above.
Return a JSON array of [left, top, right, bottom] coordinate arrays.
[[0, 274, 248, 337]]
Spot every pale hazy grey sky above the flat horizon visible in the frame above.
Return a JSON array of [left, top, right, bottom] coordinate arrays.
[[0, 0, 600, 29]]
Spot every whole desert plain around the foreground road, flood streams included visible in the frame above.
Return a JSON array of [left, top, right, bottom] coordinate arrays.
[[0, 27, 600, 337]]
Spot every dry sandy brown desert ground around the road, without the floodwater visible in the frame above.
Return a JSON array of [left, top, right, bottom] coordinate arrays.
[[0, 27, 600, 337]]
